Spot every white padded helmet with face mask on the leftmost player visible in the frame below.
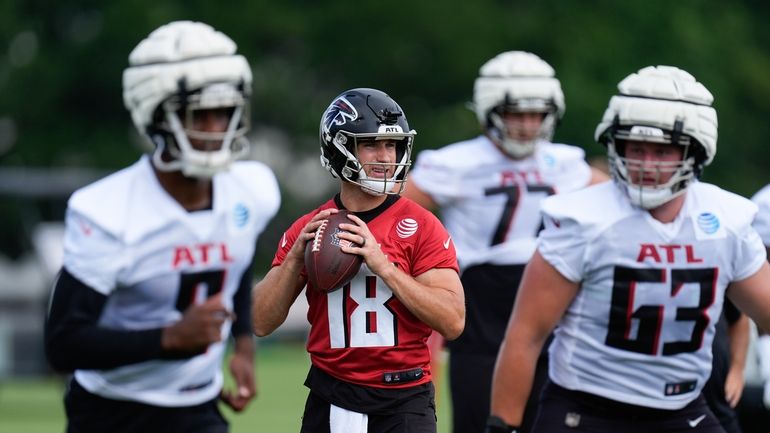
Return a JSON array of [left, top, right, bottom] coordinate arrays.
[[123, 21, 252, 177]]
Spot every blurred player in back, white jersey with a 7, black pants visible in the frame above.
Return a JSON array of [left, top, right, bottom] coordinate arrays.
[[404, 51, 607, 433]]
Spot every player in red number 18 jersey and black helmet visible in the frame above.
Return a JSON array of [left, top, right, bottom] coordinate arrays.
[[253, 88, 465, 433]]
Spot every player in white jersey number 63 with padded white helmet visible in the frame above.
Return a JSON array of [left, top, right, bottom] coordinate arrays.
[[487, 66, 770, 433]]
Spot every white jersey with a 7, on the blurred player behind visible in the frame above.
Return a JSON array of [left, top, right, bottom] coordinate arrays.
[[409, 135, 591, 269]]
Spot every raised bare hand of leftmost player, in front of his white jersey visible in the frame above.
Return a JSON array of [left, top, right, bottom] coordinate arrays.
[[161, 292, 233, 353]]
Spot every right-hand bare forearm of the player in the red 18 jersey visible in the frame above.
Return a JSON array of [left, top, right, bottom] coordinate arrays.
[[380, 266, 465, 340]]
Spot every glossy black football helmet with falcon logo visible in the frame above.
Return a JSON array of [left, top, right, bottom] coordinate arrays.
[[319, 88, 417, 195]]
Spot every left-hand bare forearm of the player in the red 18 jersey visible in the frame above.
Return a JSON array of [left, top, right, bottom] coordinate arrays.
[[251, 261, 305, 337]]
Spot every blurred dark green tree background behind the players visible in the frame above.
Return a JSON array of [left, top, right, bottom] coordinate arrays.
[[0, 0, 770, 431]]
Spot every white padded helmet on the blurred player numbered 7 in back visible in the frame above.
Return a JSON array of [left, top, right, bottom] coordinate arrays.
[[473, 51, 565, 159]]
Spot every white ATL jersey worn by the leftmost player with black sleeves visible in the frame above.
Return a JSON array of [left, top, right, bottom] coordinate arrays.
[[64, 156, 280, 406]]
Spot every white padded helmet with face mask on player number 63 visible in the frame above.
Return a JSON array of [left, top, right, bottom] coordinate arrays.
[[595, 66, 717, 209]]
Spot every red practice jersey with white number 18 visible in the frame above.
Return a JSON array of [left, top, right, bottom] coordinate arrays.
[[273, 197, 458, 388]]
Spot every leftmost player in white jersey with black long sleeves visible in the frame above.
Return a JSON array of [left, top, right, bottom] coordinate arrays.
[[46, 21, 280, 433]]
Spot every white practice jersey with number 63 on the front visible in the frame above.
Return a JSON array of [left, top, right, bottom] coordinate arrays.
[[538, 182, 765, 409]]
